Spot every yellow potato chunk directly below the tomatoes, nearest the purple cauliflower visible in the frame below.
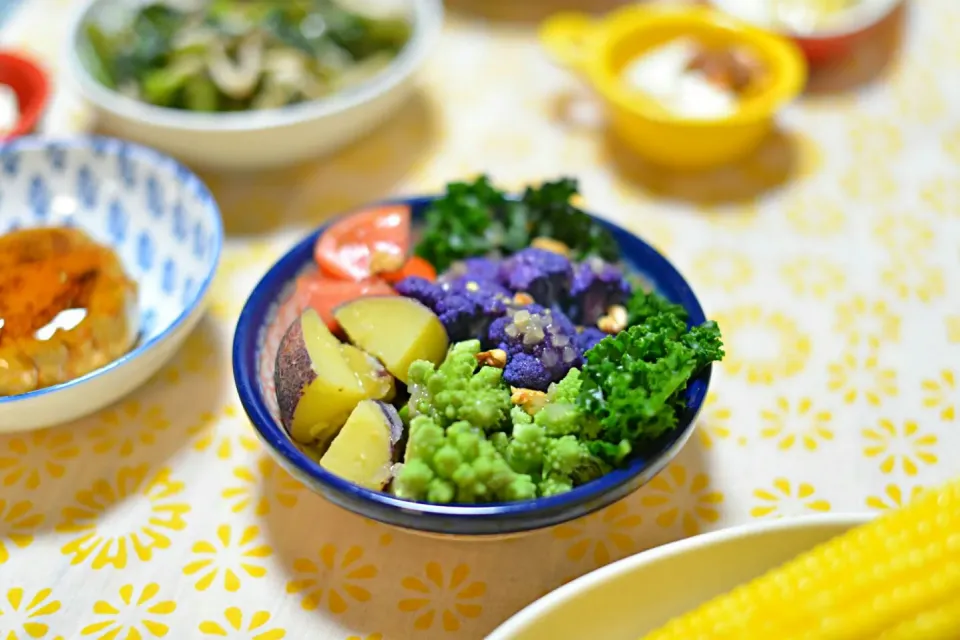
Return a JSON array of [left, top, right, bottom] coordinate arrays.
[[333, 297, 448, 384]]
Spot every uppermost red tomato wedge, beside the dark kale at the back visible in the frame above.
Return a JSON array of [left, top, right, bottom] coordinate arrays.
[[314, 205, 410, 281]]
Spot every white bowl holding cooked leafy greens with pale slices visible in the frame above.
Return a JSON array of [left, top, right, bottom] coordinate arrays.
[[65, 0, 443, 170]]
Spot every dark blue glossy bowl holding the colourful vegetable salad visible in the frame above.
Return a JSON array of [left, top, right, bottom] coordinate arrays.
[[233, 197, 711, 537]]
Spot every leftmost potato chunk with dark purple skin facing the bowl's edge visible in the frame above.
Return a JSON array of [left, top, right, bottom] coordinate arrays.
[[274, 309, 367, 446]]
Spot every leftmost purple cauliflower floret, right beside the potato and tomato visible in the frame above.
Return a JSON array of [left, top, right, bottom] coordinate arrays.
[[395, 276, 510, 342]]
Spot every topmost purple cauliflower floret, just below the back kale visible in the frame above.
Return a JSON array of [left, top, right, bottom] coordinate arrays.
[[499, 247, 573, 306]]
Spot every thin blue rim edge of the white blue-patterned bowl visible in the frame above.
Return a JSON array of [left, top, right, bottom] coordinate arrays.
[[0, 135, 224, 405]]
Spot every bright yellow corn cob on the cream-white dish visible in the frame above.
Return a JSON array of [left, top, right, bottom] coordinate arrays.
[[644, 479, 960, 640]]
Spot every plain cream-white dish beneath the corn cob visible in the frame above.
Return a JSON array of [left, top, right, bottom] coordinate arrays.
[[487, 514, 871, 640]]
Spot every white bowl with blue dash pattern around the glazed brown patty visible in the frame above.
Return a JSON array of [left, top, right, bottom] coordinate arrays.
[[0, 137, 223, 433]]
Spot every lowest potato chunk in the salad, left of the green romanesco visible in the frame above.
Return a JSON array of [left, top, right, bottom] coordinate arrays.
[[320, 400, 403, 491]]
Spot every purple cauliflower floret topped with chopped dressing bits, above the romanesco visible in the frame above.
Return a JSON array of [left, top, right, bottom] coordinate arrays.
[[488, 304, 583, 391]]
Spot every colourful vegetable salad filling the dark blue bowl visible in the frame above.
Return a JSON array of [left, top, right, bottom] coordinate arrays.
[[275, 177, 724, 504]]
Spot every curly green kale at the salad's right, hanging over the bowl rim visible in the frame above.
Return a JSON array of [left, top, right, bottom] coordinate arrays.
[[577, 292, 724, 450]]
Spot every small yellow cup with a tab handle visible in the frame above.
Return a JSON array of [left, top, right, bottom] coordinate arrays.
[[540, 5, 806, 169]]
